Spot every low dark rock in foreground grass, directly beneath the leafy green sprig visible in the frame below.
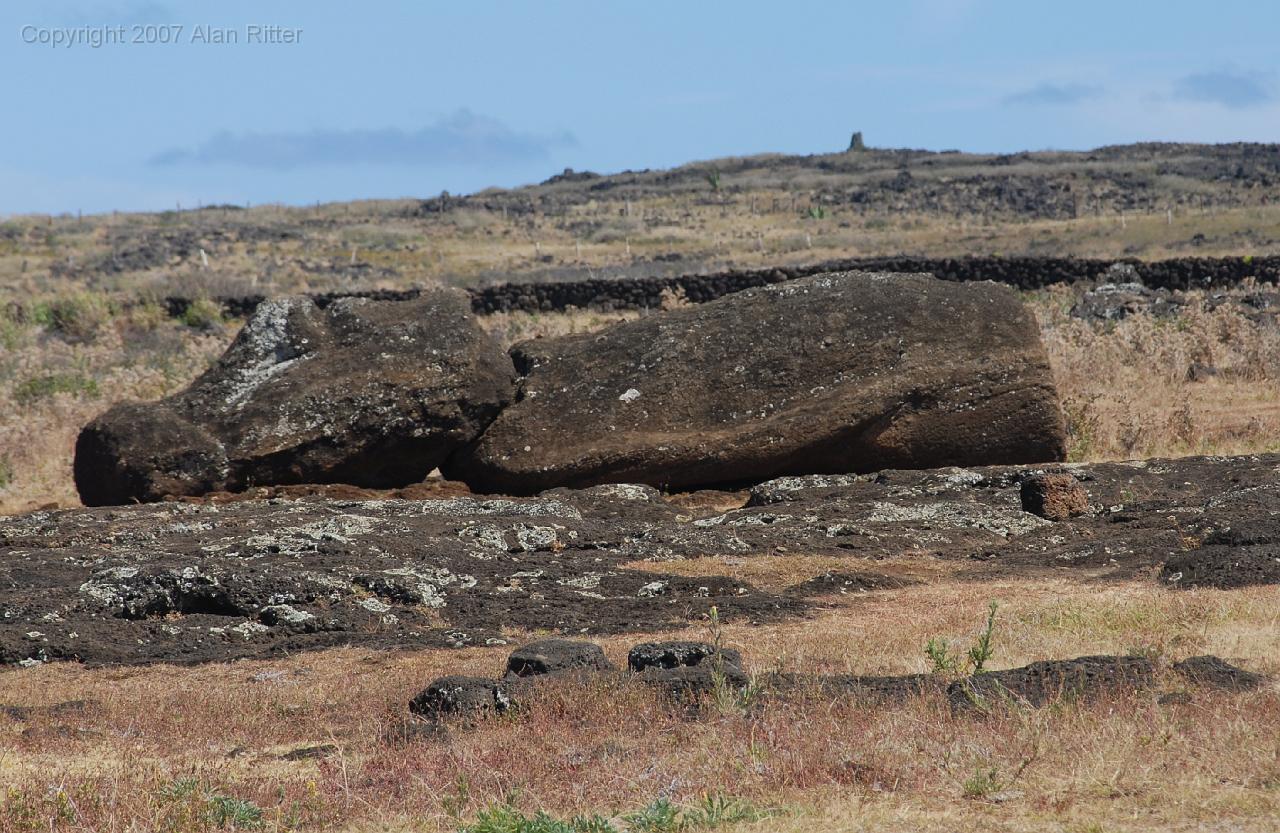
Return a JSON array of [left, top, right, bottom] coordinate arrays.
[[947, 656, 1156, 709]]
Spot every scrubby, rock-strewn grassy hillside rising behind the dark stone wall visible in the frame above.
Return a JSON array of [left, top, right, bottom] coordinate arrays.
[[0, 145, 1280, 301]]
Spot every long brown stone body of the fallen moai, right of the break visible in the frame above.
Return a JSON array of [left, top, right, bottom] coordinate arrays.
[[445, 273, 1064, 494]]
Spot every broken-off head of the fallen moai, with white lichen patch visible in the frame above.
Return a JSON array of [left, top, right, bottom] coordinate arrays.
[[76, 290, 515, 505]]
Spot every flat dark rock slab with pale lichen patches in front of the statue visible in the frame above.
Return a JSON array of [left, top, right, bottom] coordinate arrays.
[[0, 454, 1280, 664]]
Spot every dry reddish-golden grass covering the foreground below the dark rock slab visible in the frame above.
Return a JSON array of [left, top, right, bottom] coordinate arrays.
[[0, 575, 1280, 832]]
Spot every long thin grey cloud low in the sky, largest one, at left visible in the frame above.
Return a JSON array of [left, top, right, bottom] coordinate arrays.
[[148, 110, 577, 170]]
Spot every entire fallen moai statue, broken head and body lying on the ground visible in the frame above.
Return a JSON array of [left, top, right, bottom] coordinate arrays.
[[76, 273, 1065, 505]]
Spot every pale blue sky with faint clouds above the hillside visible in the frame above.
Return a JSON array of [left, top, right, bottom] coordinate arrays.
[[0, 0, 1280, 215]]
